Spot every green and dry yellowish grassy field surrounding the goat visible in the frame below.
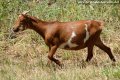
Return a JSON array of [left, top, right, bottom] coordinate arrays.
[[0, 0, 120, 80]]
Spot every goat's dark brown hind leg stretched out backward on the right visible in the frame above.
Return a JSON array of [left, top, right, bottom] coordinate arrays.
[[95, 38, 116, 62]]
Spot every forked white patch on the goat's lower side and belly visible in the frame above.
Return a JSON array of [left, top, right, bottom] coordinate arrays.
[[60, 31, 78, 48]]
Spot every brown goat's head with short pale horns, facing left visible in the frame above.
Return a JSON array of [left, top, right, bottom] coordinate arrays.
[[13, 11, 28, 32]]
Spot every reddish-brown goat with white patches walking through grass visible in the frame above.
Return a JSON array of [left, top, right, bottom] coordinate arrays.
[[13, 12, 116, 66]]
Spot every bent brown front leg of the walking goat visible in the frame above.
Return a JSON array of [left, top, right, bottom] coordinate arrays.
[[48, 45, 61, 66]]
